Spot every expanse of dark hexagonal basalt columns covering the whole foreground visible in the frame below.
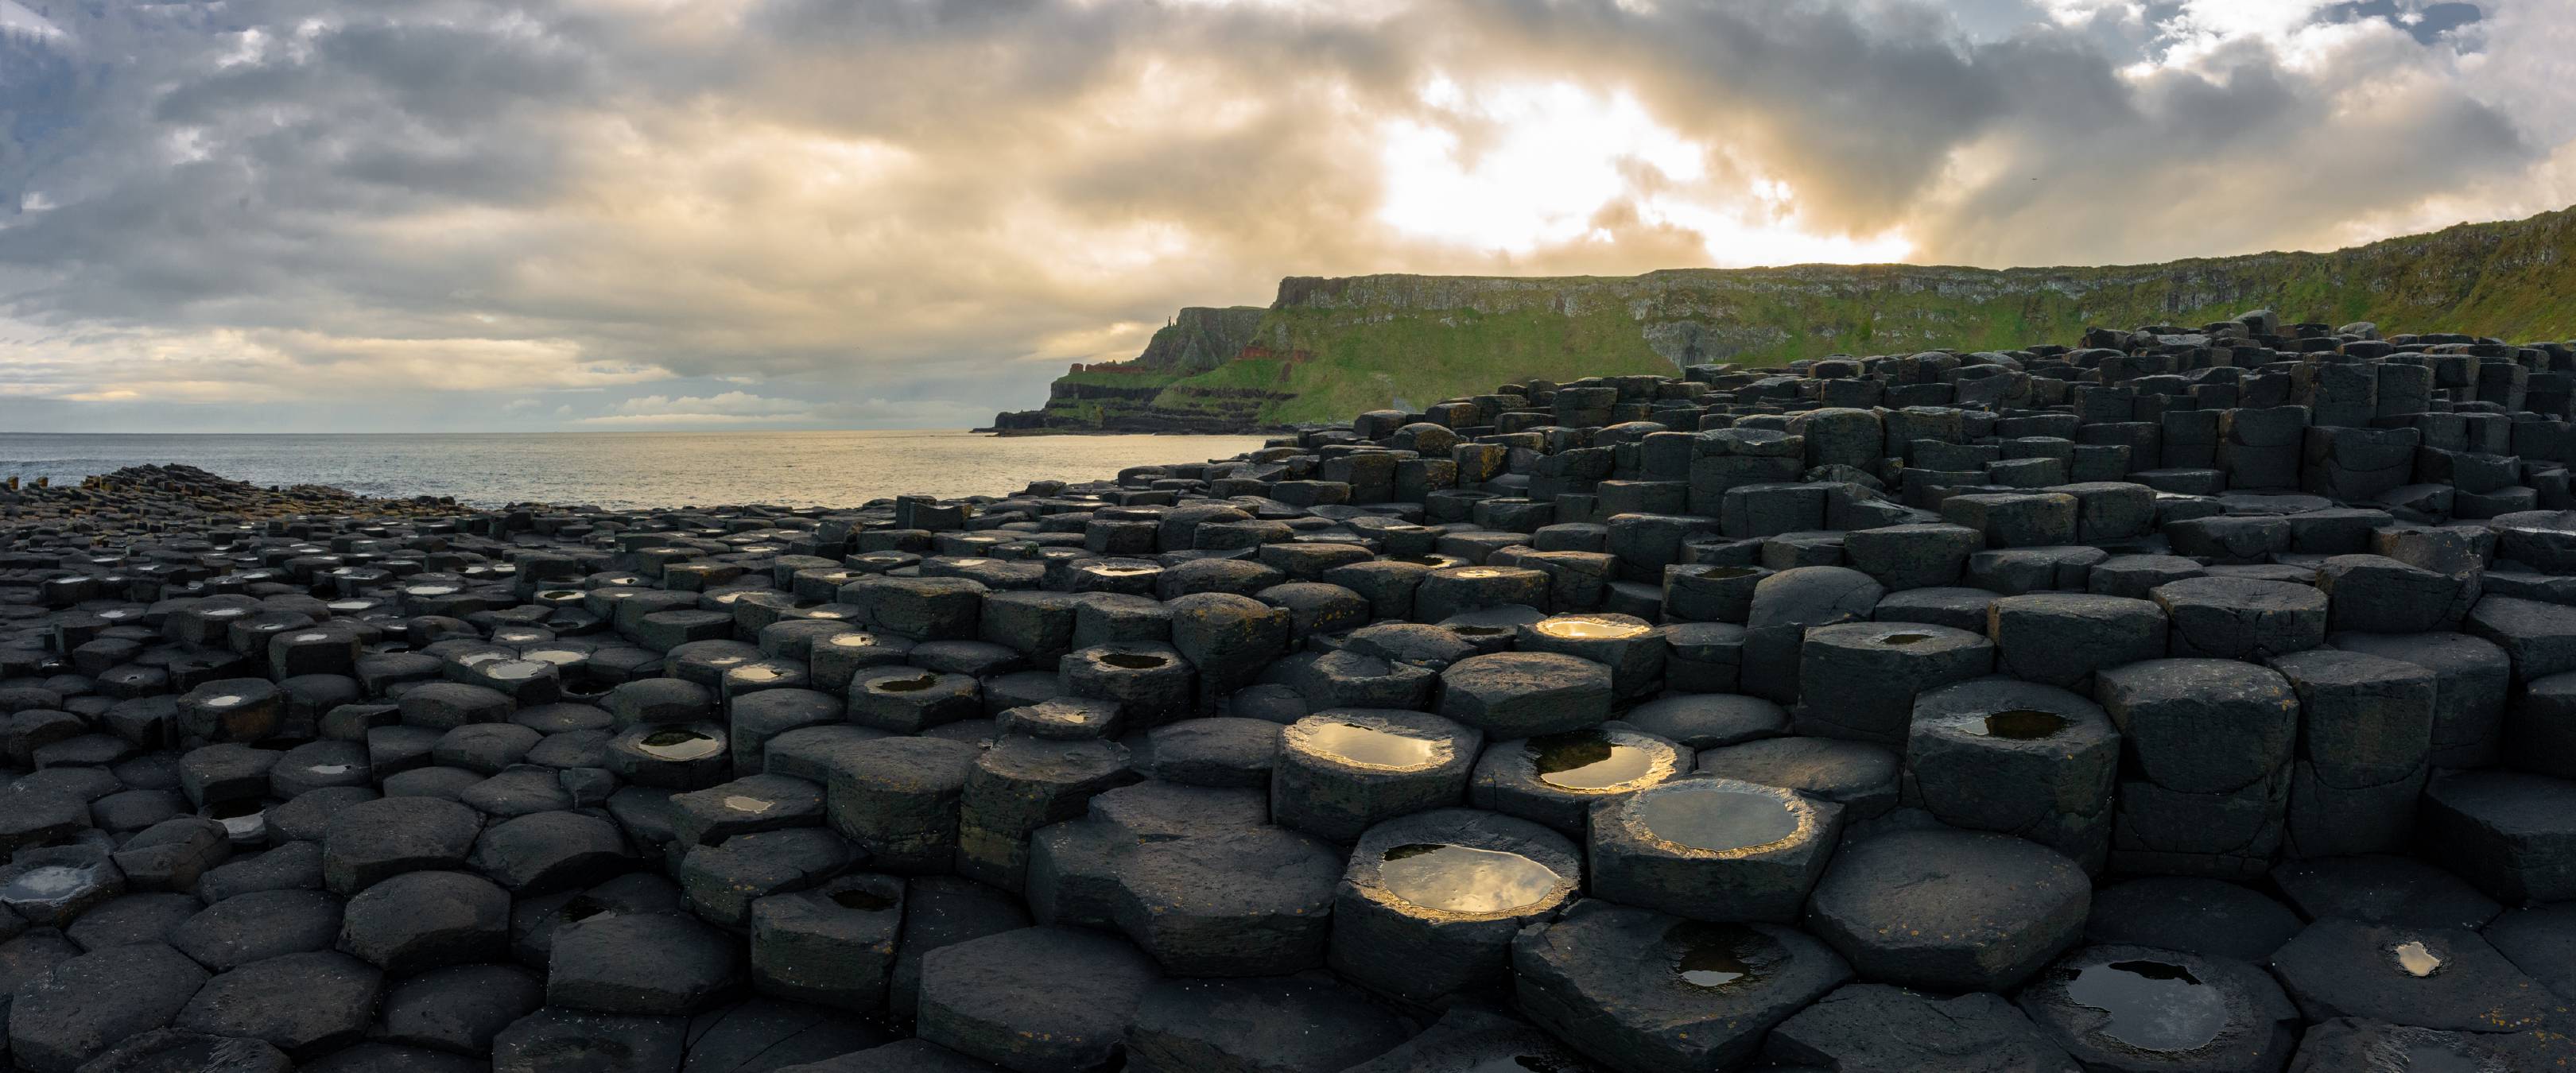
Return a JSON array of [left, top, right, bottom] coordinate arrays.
[[0, 314, 2576, 1073]]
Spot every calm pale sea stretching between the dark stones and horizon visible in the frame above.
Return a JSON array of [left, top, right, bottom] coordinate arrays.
[[0, 430, 1282, 509]]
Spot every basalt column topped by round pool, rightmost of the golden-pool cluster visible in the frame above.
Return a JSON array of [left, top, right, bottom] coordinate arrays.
[[1589, 777, 1842, 921]]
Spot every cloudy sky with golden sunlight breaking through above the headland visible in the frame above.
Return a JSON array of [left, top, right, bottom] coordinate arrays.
[[0, 0, 2576, 432]]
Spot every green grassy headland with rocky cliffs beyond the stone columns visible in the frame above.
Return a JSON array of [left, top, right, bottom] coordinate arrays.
[[995, 208, 2576, 432]]
